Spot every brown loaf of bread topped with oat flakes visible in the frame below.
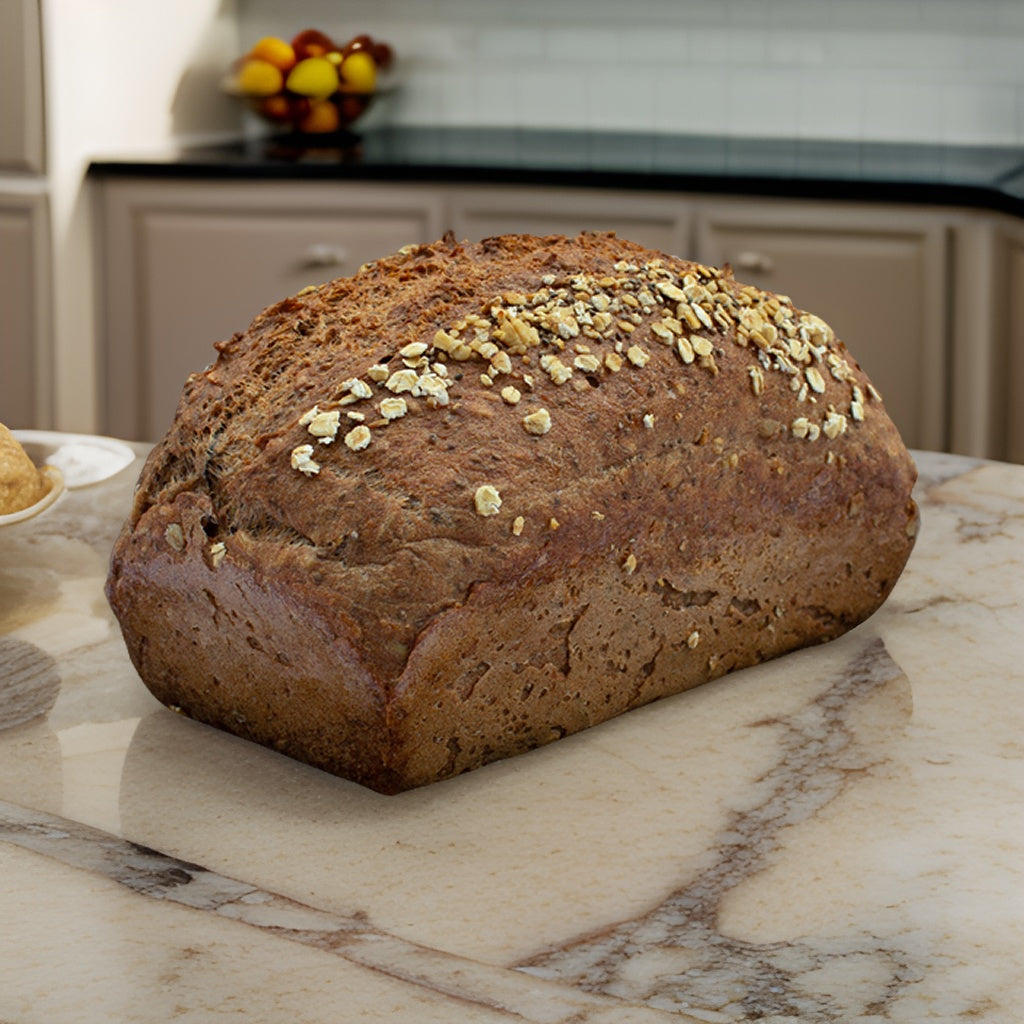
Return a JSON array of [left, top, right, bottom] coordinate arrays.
[[108, 234, 918, 794]]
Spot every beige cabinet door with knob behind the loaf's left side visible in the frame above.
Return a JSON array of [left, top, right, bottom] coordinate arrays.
[[103, 183, 437, 440]]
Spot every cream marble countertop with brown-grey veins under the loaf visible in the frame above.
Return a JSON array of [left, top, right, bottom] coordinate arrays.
[[0, 447, 1024, 1024]]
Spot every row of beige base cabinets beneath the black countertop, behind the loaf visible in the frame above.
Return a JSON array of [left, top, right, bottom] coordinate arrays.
[[98, 178, 958, 454]]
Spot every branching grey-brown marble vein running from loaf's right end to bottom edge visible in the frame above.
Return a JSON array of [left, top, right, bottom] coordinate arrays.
[[516, 639, 920, 1022]]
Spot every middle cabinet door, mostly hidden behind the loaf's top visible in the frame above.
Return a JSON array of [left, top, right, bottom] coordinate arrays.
[[451, 187, 691, 256]]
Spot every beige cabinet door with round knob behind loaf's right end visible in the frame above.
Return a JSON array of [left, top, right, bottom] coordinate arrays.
[[697, 201, 948, 450]]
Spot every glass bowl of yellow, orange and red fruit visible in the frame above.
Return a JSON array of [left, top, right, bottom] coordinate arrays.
[[224, 29, 393, 136]]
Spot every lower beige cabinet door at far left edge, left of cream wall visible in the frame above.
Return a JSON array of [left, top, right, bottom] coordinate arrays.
[[0, 190, 50, 427]]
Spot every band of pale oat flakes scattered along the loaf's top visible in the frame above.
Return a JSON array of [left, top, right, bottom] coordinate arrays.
[[291, 246, 880, 503]]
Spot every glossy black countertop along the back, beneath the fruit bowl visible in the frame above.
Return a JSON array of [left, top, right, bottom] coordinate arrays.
[[89, 127, 1024, 216]]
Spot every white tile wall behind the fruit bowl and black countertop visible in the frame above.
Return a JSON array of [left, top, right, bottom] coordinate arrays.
[[238, 0, 1024, 144]]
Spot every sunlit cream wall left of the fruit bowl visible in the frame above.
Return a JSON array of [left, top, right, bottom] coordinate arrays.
[[33, 0, 238, 430]]
